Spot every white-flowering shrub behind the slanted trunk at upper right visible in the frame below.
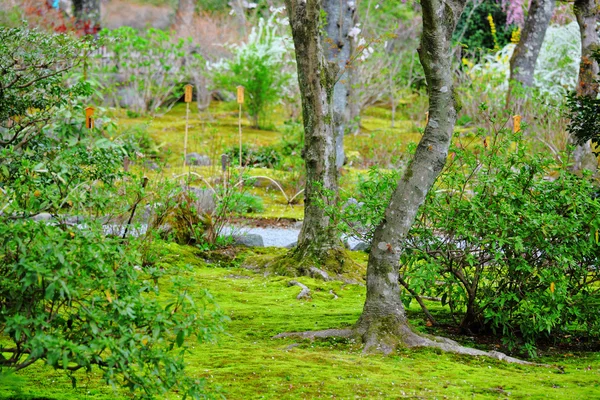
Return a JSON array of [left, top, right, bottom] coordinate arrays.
[[463, 22, 581, 99]]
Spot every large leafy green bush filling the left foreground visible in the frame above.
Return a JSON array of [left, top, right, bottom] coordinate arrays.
[[0, 28, 224, 398]]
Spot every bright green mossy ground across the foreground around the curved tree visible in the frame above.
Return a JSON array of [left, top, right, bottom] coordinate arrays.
[[0, 242, 600, 399]]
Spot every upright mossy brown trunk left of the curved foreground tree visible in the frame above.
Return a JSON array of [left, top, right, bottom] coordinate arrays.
[[285, 0, 341, 259]]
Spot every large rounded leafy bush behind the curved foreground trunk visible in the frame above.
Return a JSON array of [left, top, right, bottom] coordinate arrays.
[[332, 115, 600, 354]]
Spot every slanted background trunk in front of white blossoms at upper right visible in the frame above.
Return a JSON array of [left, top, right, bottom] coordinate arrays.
[[506, 0, 556, 106]]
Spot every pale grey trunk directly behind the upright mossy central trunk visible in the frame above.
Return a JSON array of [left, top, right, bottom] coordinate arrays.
[[322, 0, 355, 168]]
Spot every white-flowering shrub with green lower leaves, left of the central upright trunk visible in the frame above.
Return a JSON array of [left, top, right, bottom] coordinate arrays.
[[208, 8, 297, 128]]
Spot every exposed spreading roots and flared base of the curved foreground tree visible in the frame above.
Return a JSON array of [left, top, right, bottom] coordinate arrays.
[[273, 321, 544, 366]]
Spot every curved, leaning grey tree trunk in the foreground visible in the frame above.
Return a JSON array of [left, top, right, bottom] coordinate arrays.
[[356, 0, 466, 353]]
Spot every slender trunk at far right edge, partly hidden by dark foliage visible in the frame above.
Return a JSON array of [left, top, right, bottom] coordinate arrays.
[[571, 0, 600, 172]]
